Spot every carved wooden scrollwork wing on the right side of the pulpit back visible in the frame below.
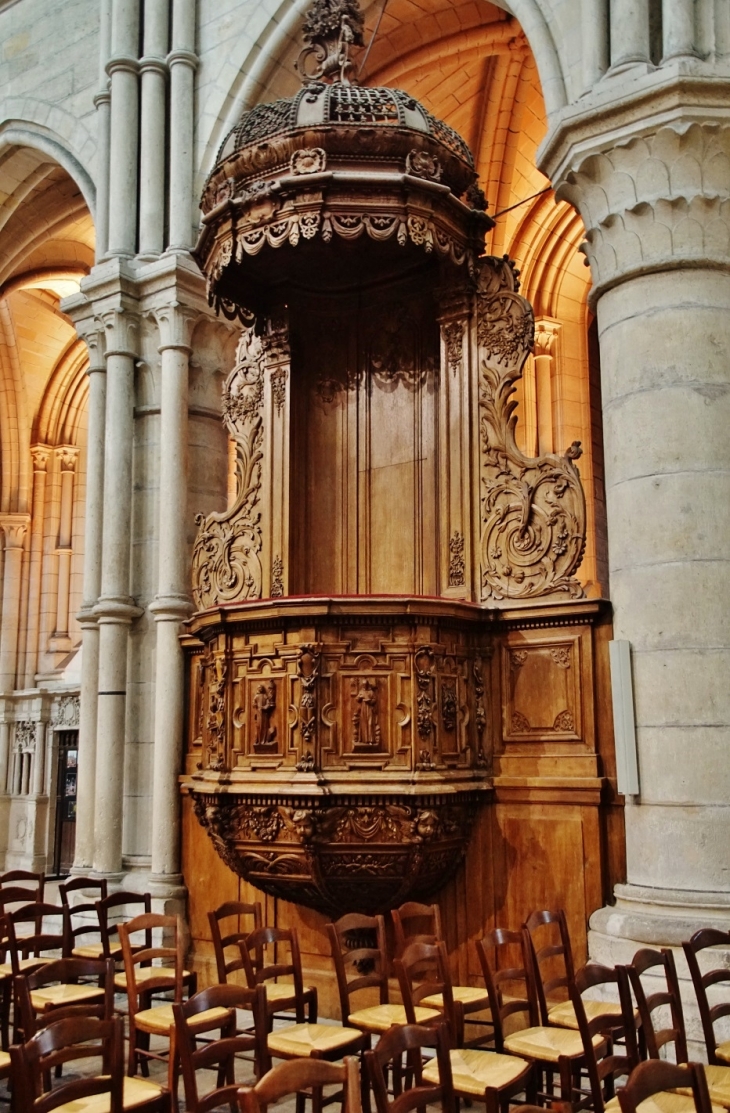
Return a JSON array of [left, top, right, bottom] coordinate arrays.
[[476, 257, 585, 602]]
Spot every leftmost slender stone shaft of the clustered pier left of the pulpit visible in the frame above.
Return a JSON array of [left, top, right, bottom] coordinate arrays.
[[73, 328, 107, 874]]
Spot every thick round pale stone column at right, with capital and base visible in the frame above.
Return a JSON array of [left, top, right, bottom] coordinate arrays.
[[543, 112, 730, 958]]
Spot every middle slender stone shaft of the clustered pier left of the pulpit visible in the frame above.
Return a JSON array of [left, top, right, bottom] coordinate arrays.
[[93, 306, 141, 878]]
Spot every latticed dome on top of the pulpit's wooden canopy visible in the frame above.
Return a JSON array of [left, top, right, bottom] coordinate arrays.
[[216, 82, 474, 169]]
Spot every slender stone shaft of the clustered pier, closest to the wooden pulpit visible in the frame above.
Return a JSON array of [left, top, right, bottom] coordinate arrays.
[[149, 305, 197, 897]]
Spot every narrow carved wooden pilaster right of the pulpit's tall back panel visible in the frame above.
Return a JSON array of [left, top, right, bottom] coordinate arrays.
[[438, 286, 475, 599]]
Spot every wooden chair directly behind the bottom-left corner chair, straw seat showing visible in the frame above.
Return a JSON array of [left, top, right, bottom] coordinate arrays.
[[14, 958, 114, 1040]]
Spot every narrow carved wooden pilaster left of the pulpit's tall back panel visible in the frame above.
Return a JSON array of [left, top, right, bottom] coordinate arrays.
[[262, 311, 292, 598]]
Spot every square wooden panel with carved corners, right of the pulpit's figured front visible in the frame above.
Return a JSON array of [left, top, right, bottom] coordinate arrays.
[[502, 633, 583, 742]]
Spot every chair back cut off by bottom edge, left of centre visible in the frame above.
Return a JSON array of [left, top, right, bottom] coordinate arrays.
[[238, 1056, 362, 1113]]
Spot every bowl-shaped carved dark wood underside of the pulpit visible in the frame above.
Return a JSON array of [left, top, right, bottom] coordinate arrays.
[[194, 790, 480, 916]]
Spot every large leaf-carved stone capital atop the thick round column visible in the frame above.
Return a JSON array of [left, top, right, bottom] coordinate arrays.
[[541, 79, 730, 302]]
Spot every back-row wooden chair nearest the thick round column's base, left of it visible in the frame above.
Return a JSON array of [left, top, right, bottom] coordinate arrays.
[[525, 908, 612, 1028]]
